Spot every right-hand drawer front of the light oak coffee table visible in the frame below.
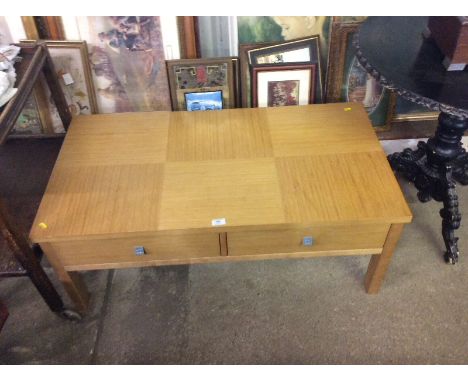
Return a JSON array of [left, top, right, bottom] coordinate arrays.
[[227, 224, 390, 256]]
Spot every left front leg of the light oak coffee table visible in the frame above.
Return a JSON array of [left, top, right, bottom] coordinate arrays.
[[41, 243, 90, 313]]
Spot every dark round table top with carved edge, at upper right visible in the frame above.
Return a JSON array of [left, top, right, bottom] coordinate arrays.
[[355, 17, 468, 117]]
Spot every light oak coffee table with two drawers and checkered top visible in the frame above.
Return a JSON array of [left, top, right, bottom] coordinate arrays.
[[30, 103, 411, 311]]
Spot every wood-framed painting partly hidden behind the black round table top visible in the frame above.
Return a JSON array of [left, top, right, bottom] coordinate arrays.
[[326, 22, 395, 129]]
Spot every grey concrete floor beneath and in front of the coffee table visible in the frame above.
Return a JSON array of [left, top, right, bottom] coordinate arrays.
[[0, 140, 468, 364]]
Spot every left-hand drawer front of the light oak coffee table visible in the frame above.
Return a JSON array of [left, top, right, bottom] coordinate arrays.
[[50, 233, 220, 270]]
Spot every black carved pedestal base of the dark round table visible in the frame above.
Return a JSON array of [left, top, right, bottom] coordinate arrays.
[[388, 113, 468, 264]]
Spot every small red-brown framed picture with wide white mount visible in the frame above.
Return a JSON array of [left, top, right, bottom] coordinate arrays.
[[252, 64, 317, 107]]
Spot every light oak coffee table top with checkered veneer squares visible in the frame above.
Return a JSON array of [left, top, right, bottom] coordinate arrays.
[[31, 103, 411, 242]]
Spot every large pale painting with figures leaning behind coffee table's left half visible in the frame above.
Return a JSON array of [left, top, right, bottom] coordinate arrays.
[[74, 16, 171, 113]]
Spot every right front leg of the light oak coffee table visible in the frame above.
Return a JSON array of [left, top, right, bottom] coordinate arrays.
[[364, 224, 403, 294]]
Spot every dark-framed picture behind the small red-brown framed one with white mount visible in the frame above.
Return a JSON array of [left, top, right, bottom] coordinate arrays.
[[247, 36, 323, 103]]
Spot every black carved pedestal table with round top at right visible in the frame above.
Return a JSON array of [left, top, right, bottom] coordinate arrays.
[[354, 17, 468, 264]]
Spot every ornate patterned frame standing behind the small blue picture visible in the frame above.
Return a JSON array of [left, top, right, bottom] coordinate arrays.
[[166, 57, 236, 111]]
